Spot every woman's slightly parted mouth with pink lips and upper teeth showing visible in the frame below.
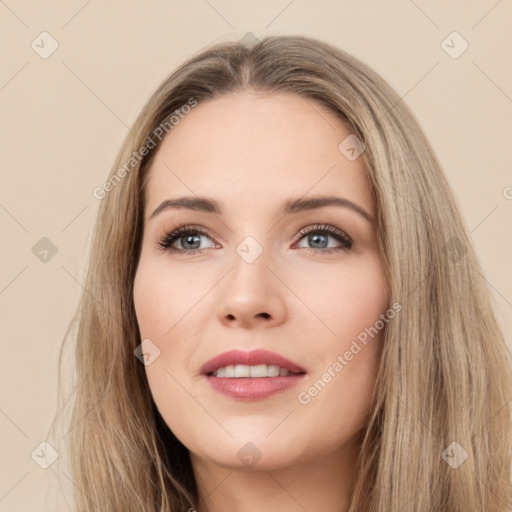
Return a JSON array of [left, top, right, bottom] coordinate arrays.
[[201, 350, 307, 401]]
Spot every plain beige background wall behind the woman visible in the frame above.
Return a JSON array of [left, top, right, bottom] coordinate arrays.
[[0, 0, 512, 512]]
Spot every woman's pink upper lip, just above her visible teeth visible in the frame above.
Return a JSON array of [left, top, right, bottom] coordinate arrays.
[[201, 349, 306, 375]]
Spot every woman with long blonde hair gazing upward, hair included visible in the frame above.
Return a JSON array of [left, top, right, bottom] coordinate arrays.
[[49, 36, 512, 512]]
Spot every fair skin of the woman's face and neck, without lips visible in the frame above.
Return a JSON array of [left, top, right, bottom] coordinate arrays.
[[134, 91, 388, 512]]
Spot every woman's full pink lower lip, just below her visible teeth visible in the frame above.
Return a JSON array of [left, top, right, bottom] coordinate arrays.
[[206, 373, 306, 400]]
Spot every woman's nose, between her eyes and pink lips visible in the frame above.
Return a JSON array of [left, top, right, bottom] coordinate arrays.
[[217, 247, 287, 328]]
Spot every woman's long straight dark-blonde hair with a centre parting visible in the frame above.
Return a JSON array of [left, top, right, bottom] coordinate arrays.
[[48, 36, 512, 512]]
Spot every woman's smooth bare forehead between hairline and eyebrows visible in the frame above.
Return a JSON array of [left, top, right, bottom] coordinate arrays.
[[142, 92, 375, 215]]
